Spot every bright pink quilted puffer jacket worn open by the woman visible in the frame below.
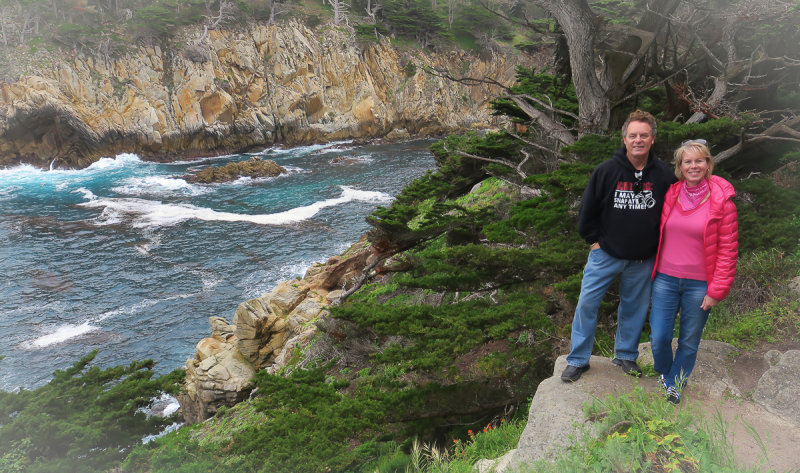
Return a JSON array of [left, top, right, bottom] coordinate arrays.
[[652, 176, 739, 301]]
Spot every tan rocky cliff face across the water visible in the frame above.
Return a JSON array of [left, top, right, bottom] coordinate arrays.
[[0, 23, 519, 167]]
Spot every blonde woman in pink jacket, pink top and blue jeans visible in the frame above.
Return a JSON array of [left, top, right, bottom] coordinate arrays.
[[650, 140, 739, 404]]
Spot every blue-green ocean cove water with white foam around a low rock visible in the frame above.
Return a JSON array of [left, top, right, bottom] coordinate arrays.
[[0, 141, 434, 391]]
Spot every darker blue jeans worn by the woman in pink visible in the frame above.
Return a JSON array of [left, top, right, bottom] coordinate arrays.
[[650, 273, 710, 388]]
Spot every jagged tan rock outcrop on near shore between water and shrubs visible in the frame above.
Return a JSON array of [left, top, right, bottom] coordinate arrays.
[[178, 241, 373, 423]]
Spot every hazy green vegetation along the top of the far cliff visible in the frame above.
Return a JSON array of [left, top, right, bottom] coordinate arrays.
[[0, 0, 541, 81]]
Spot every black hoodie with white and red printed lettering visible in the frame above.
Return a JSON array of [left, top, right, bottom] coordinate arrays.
[[578, 147, 677, 260]]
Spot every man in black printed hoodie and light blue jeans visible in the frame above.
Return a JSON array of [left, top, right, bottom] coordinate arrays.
[[561, 110, 677, 382]]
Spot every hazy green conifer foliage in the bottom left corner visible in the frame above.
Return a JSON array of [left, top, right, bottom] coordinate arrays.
[[0, 351, 183, 471]]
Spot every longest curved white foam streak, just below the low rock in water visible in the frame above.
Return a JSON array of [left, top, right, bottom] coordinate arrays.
[[79, 186, 392, 228]]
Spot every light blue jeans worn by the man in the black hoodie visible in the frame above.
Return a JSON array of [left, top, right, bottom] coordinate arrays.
[[567, 248, 655, 366]]
